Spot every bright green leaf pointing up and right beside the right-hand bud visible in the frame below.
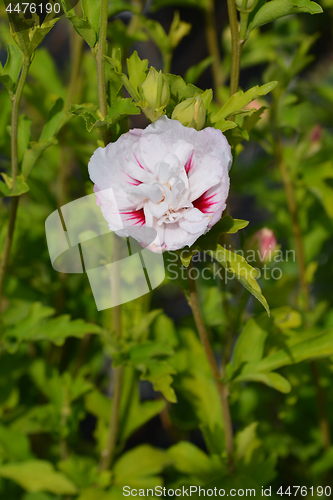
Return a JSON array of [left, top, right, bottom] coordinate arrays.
[[211, 81, 278, 124]]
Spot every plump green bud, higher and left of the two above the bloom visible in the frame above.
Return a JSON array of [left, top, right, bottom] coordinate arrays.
[[142, 67, 169, 109]]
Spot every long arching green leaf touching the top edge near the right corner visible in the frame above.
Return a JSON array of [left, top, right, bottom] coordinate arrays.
[[248, 0, 323, 33]]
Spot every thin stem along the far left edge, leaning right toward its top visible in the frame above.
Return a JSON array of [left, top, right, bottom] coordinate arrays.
[[0, 57, 31, 313]]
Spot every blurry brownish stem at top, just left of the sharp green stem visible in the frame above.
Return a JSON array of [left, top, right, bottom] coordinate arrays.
[[205, 0, 224, 100]]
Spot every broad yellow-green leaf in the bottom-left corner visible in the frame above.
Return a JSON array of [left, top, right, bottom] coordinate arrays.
[[0, 460, 77, 495]]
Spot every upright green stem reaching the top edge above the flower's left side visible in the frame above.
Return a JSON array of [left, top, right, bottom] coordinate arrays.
[[96, 0, 109, 117]]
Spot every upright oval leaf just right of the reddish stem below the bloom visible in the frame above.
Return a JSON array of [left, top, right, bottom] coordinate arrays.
[[232, 318, 267, 370]]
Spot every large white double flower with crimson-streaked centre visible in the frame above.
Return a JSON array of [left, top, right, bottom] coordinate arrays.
[[88, 116, 232, 251]]
